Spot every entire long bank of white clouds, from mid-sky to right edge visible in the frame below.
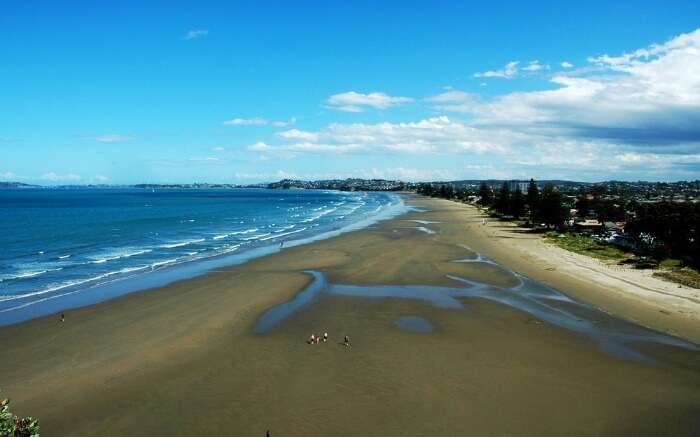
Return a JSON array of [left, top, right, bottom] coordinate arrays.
[[249, 29, 700, 177]]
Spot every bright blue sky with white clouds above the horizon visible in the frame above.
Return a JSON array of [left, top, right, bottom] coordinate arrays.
[[0, 0, 700, 185]]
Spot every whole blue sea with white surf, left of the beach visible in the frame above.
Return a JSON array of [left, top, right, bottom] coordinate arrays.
[[0, 188, 404, 325]]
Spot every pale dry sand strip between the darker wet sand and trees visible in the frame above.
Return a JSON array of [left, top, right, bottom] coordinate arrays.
[[454, 201, 700, 343]]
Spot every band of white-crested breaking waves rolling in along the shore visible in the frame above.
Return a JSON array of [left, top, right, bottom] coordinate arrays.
[[0, 194, 404, 323]]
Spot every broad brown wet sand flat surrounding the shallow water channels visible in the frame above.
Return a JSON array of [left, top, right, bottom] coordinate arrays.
[[0, 196, 700, 436]]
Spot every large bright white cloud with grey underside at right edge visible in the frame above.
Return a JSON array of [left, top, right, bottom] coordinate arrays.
[[472, 30, 700, 144]]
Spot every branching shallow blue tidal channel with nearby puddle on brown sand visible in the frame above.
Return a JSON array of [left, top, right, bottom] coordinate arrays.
[[254, 250, 700, 364]]
